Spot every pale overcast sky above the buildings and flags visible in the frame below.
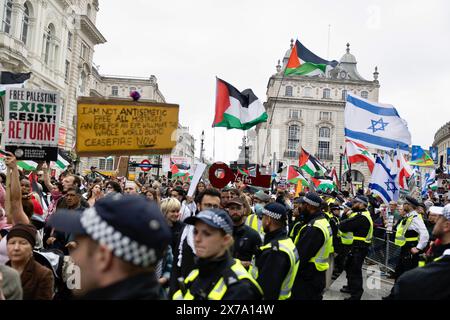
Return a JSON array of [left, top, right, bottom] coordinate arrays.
[[94, 0, 450, 161]]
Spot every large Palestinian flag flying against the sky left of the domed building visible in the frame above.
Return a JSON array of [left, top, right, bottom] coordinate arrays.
[[212, 78, 267, 130]]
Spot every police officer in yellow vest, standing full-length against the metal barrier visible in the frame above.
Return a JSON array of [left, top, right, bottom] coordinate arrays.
[[339, 195, 373, 300]]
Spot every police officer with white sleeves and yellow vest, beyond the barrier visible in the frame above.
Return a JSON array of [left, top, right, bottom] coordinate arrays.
[[395, 196, 430, 279]]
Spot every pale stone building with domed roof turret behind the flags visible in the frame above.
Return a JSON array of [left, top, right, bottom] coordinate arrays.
[[253, 40, 380, 185]]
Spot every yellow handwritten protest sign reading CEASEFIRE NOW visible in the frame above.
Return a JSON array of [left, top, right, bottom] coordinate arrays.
[[76, 97, 179, 156]]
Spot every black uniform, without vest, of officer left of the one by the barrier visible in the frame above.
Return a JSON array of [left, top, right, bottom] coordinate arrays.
[[291, 210, 326, 300]]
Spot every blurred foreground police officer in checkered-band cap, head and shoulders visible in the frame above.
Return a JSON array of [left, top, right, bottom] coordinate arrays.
[[49, 193, 171, 300]]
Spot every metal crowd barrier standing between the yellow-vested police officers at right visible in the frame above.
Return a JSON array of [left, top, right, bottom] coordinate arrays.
[[366, 227, 400, 273]]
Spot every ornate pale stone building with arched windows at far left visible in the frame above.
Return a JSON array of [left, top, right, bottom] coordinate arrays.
[[0, 0, 106, 150]]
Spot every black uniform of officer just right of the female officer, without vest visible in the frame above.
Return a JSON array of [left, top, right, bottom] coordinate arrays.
[[255, 228, 291, 300]]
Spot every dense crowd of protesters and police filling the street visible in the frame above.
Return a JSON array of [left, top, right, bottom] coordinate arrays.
[[0, 154, 450, 300]]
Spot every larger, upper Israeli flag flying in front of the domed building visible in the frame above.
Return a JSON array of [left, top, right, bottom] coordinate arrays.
[[344, 93, 411, 153]]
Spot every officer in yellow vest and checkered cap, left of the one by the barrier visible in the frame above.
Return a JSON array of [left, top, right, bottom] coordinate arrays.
[[291, 192, 333, 300]]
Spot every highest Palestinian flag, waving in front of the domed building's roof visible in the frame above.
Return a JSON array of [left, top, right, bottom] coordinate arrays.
[[284, 40, 337, 76]]
